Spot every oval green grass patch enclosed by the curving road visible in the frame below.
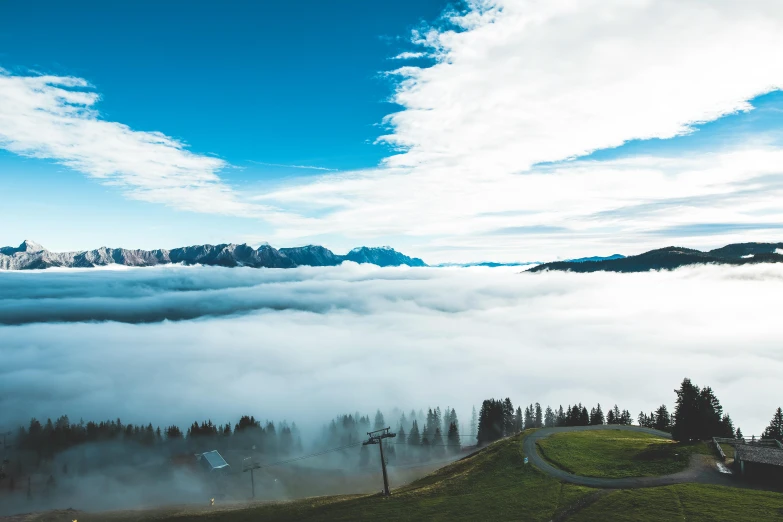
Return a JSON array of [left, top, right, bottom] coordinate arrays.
[[538, 430, 709, 478]]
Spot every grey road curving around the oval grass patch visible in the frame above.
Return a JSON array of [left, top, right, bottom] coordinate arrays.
[[522, 425, 739, 489]]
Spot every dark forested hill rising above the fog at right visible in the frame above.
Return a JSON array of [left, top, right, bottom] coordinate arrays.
[[528, 243, 783, 272]]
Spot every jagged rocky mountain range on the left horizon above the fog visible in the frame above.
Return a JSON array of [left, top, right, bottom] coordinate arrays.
[[0, 241, 427, 270]]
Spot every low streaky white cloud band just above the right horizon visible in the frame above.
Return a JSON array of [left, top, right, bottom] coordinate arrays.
[[263, 143, 783, 262]]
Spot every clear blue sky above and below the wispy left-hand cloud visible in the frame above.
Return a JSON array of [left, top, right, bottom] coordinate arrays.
[[0, 0, 446, 249]]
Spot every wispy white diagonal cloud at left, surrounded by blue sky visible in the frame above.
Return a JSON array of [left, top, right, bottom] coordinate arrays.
[[0, 69, 269, 216]]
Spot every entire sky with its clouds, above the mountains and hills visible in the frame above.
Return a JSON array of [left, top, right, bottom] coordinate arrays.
[[0, 0, 783, 261]]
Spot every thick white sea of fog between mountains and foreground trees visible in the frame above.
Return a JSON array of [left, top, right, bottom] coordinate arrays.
[[0, 263, 783, 434]]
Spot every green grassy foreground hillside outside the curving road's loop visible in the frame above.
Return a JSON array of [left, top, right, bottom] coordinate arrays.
[[14, 432, 783, 522]]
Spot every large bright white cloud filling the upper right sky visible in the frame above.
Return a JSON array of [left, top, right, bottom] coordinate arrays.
[[384, 0, 783, 171]]
